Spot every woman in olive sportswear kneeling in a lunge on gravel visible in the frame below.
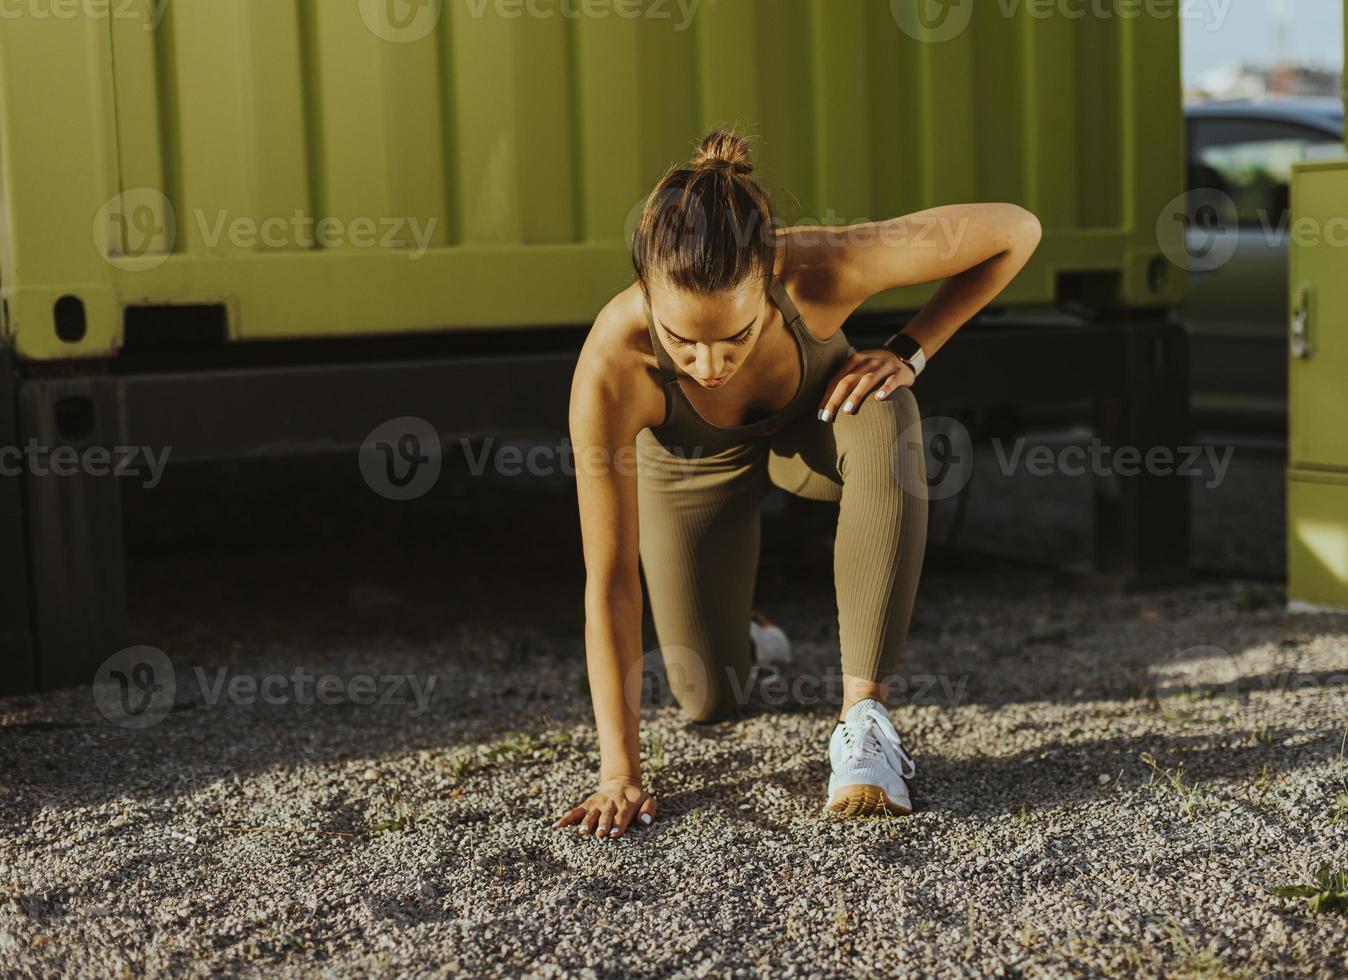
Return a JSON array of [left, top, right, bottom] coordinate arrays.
[[554, 131, 1039, 838]]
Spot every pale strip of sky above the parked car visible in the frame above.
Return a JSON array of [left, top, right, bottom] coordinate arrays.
[[1180, 0, 1344, 85]]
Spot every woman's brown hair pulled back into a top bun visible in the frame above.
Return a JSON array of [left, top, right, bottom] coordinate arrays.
[[632, 129, 776, 297]]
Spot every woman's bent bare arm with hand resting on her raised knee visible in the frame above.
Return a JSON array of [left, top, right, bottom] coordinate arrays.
[[820, 204, 1041, 419]]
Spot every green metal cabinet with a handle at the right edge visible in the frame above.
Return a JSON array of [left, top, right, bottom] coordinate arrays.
[[1287, 160, 1348, 608]]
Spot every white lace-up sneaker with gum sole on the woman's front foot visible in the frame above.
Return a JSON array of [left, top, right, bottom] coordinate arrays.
[[828, 698, 917, 817]]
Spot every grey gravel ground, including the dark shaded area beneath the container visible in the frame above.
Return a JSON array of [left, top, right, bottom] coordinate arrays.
[[0, 425, 1348, 977]]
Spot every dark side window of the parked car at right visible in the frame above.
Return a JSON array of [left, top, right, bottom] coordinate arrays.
[[1189, 119, 1343, 228]]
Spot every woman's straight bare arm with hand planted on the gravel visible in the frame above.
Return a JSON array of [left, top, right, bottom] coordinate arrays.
[[555, 305, 663, 837]]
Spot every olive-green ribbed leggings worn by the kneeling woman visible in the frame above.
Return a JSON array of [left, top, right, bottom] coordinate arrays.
[[638, 388, 927, 721]]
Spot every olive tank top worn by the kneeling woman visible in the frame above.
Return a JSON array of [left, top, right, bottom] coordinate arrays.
[[643, 276, 852, 456]]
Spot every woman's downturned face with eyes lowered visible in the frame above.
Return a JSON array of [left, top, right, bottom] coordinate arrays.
[[650, 279, 767, 388]]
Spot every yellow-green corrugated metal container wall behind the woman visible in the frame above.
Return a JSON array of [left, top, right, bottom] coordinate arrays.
[[0, 0, 1184, 359]]
